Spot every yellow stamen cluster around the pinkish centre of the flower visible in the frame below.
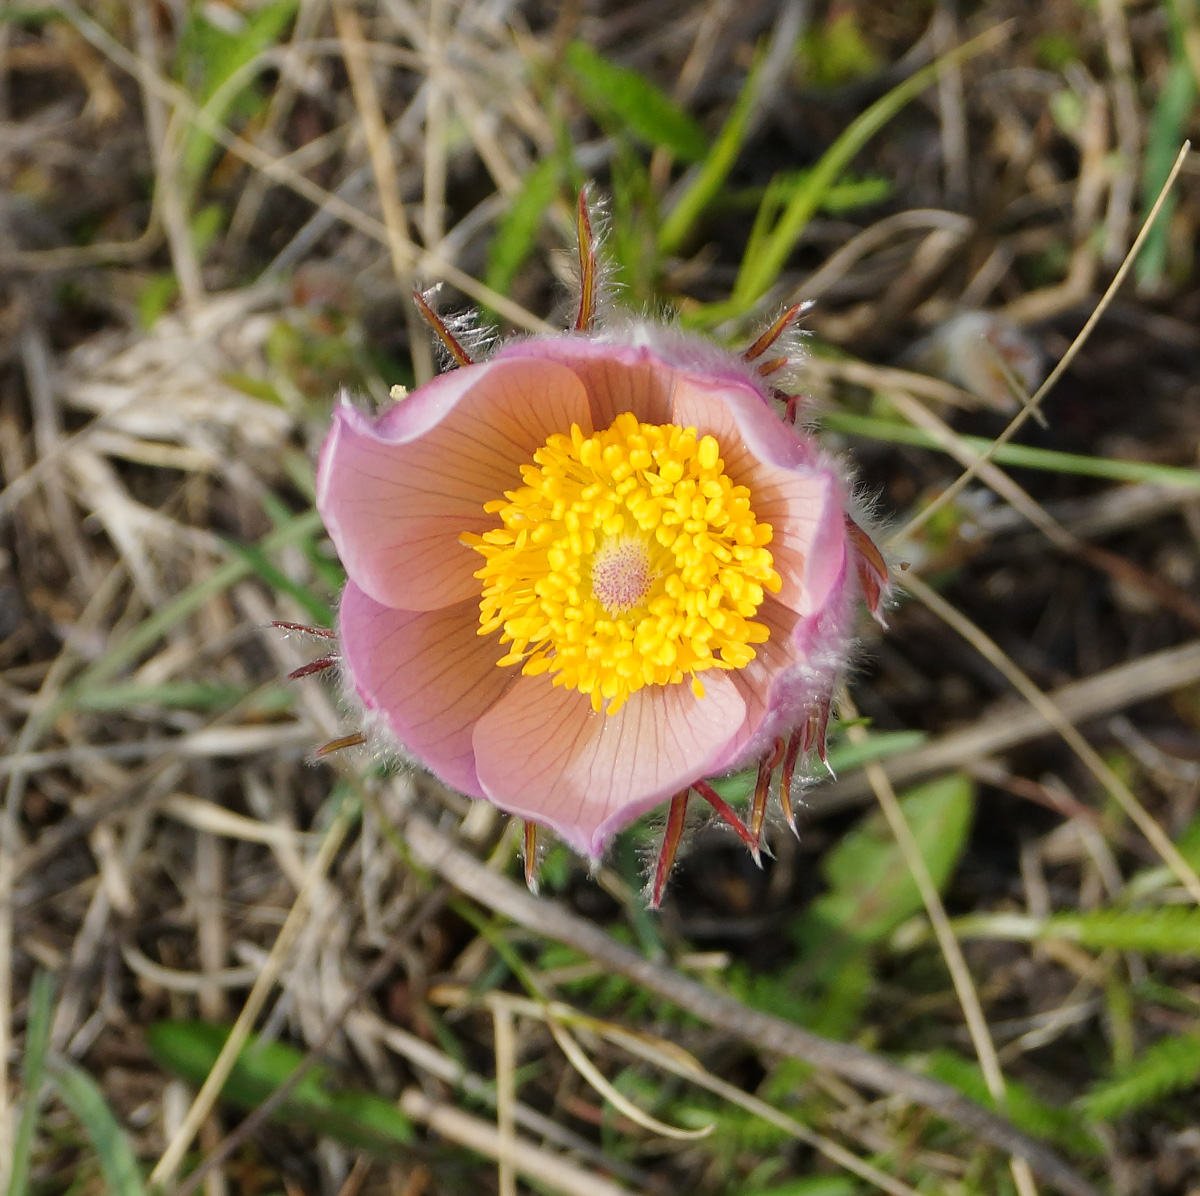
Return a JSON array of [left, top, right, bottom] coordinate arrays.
[[462, 413, 780, 714]]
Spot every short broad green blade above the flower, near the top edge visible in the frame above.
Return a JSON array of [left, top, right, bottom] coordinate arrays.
[[565, 41, 708, 162]]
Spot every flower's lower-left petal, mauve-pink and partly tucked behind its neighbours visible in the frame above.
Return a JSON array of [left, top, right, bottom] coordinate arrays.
[[338, 582, 515, 798]]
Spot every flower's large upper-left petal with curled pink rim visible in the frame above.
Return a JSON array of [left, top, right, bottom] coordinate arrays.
[[317, 359, 593, 611]]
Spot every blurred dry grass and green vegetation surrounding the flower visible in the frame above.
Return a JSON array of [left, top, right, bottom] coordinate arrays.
[[0, 0, 1200, 1196]]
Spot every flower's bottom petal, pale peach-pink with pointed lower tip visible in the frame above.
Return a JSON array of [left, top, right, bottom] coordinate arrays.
[[474, 669, 745, 859]]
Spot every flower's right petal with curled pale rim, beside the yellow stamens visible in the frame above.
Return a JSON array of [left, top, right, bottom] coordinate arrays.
[[673, 377, 846, 615]]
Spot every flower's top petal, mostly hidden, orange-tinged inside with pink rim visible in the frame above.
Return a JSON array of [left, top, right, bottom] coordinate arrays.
[[493, 337, 677, 431]]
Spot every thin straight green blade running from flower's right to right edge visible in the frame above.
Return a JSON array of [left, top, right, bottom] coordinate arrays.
[[821, 411, 1200, 491]]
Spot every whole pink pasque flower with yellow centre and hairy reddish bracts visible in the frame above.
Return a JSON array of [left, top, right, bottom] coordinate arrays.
[[317, 195, 887, 900]]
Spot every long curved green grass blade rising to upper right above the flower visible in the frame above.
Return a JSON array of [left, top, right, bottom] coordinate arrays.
[[728, 30, 996, 314]]
